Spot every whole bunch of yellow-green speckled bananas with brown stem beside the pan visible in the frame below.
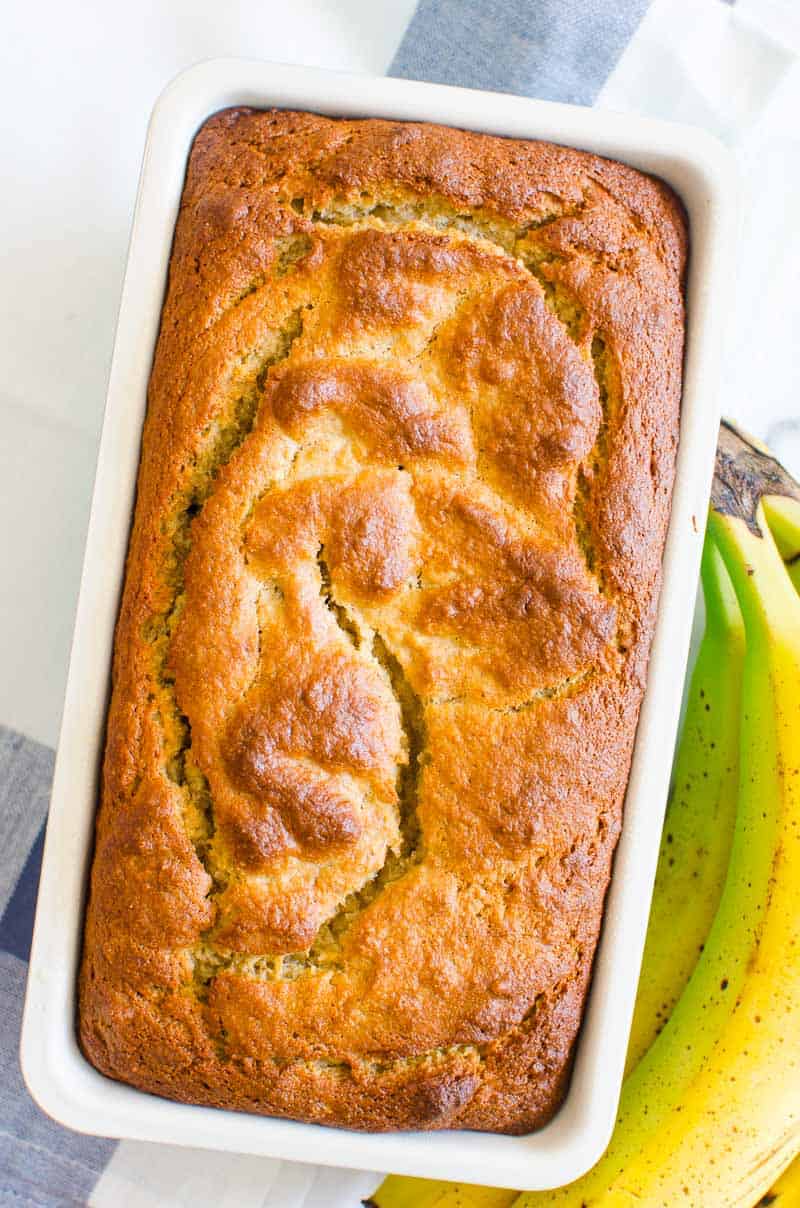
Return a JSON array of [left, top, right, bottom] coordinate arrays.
[[372, 424, 800, 1208]]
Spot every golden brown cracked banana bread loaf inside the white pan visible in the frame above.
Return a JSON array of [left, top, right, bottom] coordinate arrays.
[[80, 110, 685, 1132]]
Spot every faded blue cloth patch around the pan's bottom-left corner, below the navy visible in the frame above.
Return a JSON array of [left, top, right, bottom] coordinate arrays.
[[0, 952, 117, 1208]]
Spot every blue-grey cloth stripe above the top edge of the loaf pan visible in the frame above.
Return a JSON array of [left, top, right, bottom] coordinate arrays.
[[389, 0, 649, 105]]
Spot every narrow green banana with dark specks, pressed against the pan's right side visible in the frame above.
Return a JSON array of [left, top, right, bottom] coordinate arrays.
[[626, 538, 744, 1071]]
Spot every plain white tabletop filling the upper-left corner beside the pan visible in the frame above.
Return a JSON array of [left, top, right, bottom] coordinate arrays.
[[0, 0, 416, 744]]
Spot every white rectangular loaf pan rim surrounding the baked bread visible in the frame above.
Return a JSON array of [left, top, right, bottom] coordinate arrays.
[[22, 59, 736, 1190]]
